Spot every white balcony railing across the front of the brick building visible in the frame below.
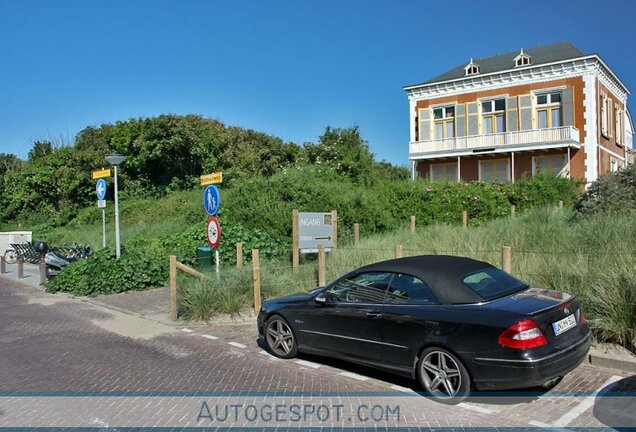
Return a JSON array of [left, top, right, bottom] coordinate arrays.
[[409, 126, 581, 156]]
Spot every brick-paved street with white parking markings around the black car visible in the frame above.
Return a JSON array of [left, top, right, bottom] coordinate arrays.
[[0, 278, 636, 430]]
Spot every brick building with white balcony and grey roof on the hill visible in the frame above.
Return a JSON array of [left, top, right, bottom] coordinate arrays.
[[404, 43, 634, 184]]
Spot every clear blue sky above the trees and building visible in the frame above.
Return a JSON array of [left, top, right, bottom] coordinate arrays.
[[0, 0, 636, 165]]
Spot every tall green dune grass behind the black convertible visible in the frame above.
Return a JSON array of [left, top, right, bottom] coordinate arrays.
[[182, 208, 636, 348]]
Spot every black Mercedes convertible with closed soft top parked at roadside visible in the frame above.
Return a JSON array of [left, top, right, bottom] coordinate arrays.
[[258, 255, 591, 403]]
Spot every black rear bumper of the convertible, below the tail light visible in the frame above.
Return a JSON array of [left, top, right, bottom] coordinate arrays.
[[471, 332, 592, 390]]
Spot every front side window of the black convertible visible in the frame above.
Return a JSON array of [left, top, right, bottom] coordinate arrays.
[[325, 272, 393, 304]]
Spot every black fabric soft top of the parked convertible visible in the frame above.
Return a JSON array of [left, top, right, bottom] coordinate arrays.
[[356, 255, 494, 304]]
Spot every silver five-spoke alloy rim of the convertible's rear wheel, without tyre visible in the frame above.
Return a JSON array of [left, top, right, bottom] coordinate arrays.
[[420, 351, 462, 399]]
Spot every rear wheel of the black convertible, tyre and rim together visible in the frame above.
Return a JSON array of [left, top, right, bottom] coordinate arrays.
[[417, 347, 470, 404]]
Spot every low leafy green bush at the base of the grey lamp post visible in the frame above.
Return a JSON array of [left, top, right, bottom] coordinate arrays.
[[46, 249, 168, 296]]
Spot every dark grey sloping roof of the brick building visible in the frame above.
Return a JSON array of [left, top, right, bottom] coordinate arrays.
[[420, 42, 585, 85]]
